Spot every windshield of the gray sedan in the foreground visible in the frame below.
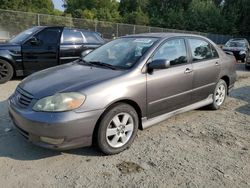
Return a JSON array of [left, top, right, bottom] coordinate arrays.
[[83, 38, 158, 69]]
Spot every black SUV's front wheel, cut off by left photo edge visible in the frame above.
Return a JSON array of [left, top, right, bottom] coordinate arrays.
[[0, 59, 14, 84]]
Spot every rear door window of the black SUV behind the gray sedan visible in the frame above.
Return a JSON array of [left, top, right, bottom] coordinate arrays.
[[61, 29, 84, 44]]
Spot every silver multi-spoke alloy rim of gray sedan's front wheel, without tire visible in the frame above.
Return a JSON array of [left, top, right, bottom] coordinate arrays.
[[106, 113, 134, 148]]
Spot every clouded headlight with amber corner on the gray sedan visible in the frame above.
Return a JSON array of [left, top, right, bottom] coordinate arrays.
[[33, 92, 86, 112]]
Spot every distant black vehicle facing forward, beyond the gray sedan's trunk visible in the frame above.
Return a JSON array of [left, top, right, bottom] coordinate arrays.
[[223, 38, 250, 63]]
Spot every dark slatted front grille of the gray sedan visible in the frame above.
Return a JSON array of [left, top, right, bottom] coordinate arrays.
[[15, 87, 34, 108]]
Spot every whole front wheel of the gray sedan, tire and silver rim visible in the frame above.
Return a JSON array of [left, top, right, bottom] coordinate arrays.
[[95, 103, 139, 155]]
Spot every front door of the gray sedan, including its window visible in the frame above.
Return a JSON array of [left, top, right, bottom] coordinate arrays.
[[147, 38, 193, 118]]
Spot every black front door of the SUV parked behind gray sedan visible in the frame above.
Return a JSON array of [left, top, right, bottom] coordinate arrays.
[[22, 27, 61, 74]]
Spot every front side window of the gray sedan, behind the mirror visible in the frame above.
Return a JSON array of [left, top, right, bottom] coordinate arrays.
[[152, 39, 187, 66]]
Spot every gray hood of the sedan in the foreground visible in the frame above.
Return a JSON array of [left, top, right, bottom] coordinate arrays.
[[18, 62, 124, 99]]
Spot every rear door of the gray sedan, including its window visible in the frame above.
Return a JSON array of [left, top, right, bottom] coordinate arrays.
[[188, 38, 221, 102]]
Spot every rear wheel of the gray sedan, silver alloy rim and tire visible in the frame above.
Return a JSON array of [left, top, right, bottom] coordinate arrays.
[[209, 80, 228, 110]]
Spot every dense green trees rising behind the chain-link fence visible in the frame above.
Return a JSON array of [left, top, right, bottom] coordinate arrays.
[[0, 0, 250, 36]]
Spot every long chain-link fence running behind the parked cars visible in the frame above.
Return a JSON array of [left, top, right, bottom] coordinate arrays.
[[0, 9, 249, 44]]
